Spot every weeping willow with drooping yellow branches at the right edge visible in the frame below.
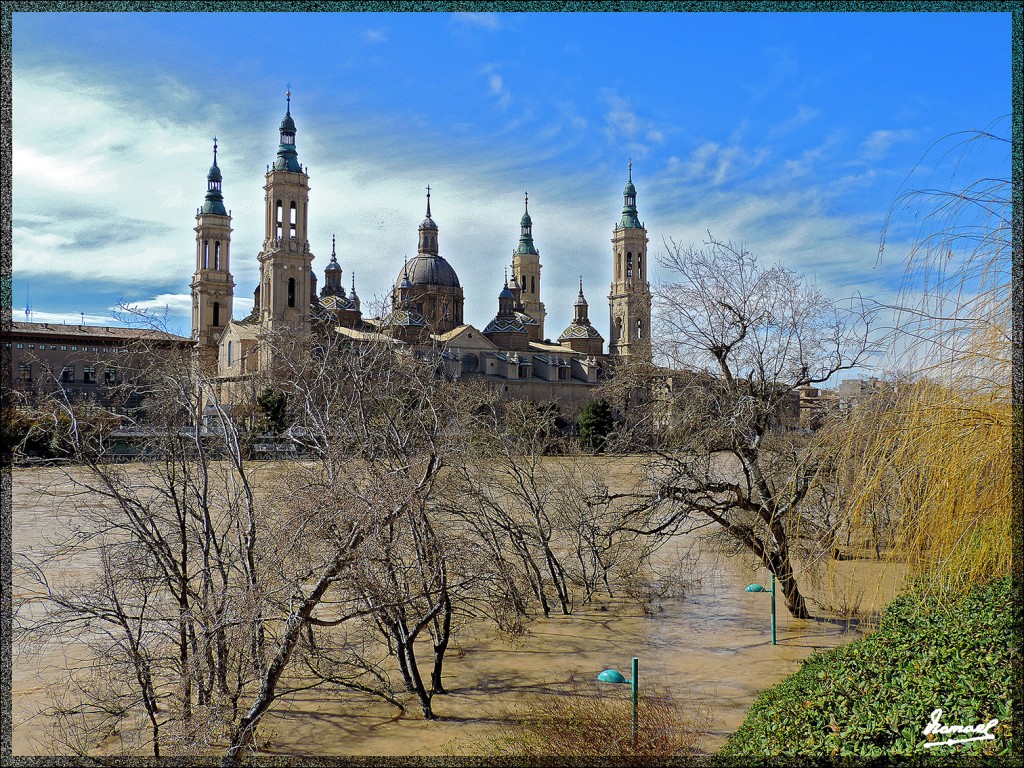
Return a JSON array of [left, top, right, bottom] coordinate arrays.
[[826, 121, 1020, 589]]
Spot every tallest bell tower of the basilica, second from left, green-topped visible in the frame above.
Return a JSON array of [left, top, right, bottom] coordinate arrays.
[[258, 90, 313, 368]]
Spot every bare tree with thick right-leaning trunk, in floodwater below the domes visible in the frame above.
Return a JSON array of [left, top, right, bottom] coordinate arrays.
[[216, 325, 487, 766]]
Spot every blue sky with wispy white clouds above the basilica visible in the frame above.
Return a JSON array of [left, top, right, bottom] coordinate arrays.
[[12, 12, 1012, 374]]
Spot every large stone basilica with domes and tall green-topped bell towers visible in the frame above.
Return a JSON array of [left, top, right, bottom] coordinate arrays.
[[191, 94, 651, 406]]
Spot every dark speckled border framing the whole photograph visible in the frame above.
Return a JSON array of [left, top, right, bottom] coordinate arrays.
[[0, 0, 1024, 768]]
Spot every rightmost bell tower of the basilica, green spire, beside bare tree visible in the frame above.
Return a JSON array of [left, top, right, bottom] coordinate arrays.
[[608, 163, 651, 360]]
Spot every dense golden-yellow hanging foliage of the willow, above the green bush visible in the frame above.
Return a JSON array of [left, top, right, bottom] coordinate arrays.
[[837, 370, 1012, 589]]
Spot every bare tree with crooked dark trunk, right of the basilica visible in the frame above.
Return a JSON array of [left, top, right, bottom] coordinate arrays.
[[634, 239, 872, 618]]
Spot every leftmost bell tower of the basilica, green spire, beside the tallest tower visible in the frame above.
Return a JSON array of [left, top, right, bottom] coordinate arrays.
[[191, 137, 234, 368]]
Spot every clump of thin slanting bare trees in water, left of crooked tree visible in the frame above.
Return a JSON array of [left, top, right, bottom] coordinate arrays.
[[453, 400, 664, 616]]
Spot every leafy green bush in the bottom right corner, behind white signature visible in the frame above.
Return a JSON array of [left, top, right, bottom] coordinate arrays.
[[721, 578, 1019, 762]]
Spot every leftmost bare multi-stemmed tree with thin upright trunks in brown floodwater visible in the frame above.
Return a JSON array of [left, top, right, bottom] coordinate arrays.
[[15, 325, 263, 756]]
